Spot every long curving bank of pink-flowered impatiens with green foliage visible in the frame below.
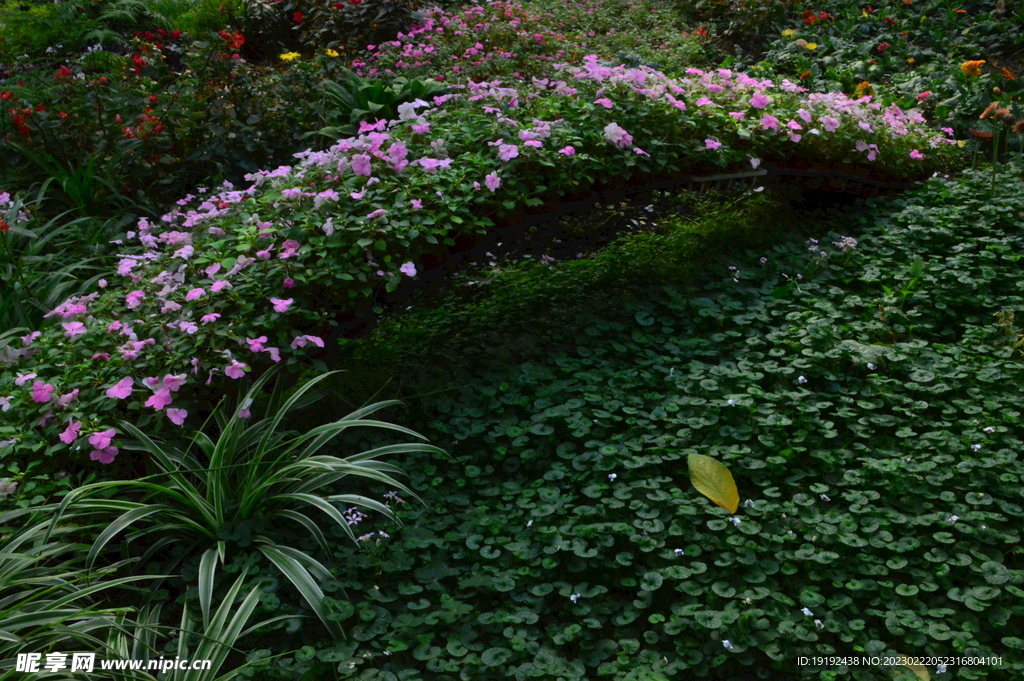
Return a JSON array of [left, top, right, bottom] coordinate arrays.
[[0, 55, 952, 503]]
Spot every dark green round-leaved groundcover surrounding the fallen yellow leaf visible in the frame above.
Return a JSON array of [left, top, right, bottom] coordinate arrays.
[[241, 168, 1024, 681]]
